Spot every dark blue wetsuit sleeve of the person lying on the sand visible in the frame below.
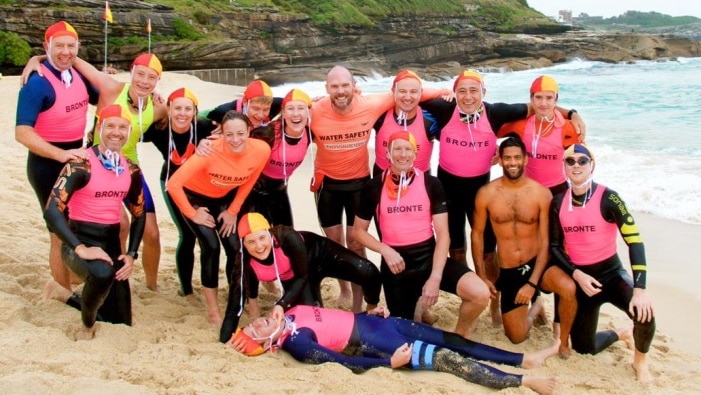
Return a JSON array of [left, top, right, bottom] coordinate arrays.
[[282, 328, 392, 373]]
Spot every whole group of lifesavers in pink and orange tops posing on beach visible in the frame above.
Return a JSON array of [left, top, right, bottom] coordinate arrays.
[[16, 21, 655, 393]]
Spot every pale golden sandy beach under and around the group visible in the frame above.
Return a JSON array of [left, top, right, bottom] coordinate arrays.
[[0, 73, 701, 395]]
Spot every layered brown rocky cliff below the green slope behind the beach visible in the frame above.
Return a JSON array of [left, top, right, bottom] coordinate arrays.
[[0, 0, 701, 84]]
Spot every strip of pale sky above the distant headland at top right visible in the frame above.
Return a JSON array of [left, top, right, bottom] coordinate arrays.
[[527, 0, 701, 18]]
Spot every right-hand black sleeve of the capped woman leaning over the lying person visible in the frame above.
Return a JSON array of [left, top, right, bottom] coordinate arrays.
[[275, 227, 309, 310]]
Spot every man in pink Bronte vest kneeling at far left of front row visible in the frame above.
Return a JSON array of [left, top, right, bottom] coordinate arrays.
[[44, 104, 146, 340]]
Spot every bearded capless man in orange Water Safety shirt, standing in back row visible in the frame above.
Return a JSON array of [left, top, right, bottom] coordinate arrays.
[[311, 66, 450, 312]]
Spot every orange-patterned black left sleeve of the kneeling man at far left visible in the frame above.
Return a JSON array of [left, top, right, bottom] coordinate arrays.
[[44, 159, 90, 249]]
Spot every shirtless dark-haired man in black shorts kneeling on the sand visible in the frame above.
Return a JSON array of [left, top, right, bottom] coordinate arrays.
[[471, 137, 576, 356]]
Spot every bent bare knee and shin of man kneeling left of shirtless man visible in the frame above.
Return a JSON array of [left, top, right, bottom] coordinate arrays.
[[455, 272, 489, 339]]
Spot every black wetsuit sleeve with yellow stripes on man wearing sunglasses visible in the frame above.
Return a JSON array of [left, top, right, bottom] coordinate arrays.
[[601, 188, 647, 289]]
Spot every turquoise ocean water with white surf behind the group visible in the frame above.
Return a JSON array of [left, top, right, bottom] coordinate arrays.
[[273, 58, 701, 224]]
